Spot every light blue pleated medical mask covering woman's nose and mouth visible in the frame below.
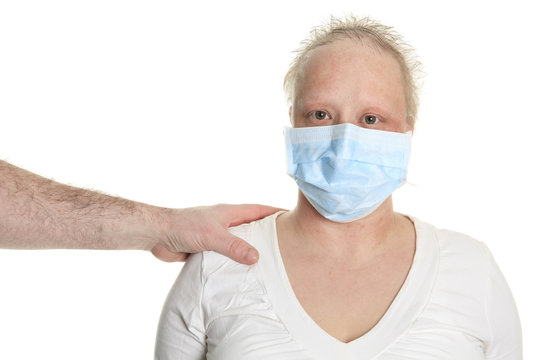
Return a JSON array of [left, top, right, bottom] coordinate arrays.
[[285, 123, 412, 222]]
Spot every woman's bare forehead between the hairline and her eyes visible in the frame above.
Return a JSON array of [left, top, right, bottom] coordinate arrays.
[[295, 39, 404, 108]]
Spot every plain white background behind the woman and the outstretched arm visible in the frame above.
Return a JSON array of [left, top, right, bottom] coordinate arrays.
[[0, 0, 540, 359]]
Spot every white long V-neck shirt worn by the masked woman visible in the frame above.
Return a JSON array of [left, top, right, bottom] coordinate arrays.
[[155, 214, 522, 360]]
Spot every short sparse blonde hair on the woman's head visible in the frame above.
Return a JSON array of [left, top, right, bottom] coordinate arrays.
[[283, 16, 421, 127]]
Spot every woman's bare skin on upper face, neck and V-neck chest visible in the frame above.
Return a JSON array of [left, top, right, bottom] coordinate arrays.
[[277, 39, 416, 343]]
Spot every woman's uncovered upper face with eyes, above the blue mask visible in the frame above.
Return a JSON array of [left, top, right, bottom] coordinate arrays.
[[289, 39, 412, 132]]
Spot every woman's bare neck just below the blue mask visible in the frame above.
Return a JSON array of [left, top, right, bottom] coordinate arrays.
[[278, 192, 405, 264]]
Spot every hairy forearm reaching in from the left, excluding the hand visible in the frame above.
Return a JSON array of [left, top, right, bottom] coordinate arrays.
[[0, 161, 165, 249]]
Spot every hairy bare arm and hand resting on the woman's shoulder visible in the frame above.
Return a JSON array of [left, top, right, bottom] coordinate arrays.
[[0, 161, 278, 265]]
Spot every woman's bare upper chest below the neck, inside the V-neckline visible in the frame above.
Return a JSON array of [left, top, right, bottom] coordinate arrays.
[[288, 256, 412, 343]]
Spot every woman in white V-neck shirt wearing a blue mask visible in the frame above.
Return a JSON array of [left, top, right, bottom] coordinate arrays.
[[156, 18, 521, 360]]
